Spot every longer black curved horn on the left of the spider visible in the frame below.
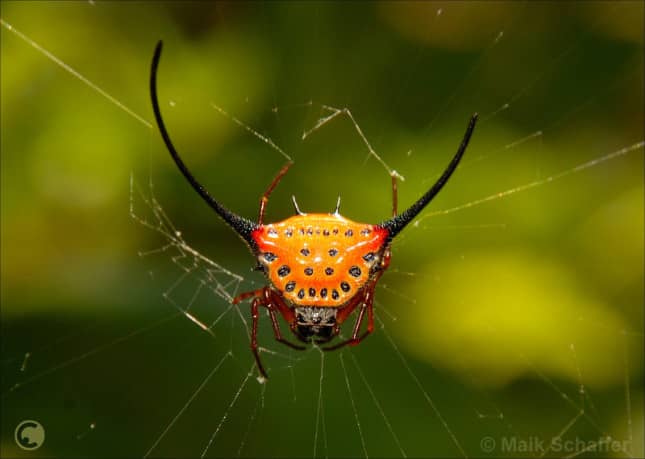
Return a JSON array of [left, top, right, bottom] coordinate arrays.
[[150, 41, 258, 247]]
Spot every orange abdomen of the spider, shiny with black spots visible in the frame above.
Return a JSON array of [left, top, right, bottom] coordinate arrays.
[[252, 214, 388, 307]]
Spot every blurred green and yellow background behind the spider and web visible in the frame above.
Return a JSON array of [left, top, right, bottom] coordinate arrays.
[[0, 1, 644, 457]]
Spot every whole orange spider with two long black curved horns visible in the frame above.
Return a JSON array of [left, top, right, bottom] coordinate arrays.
[[150, 41, 477, 378]]
